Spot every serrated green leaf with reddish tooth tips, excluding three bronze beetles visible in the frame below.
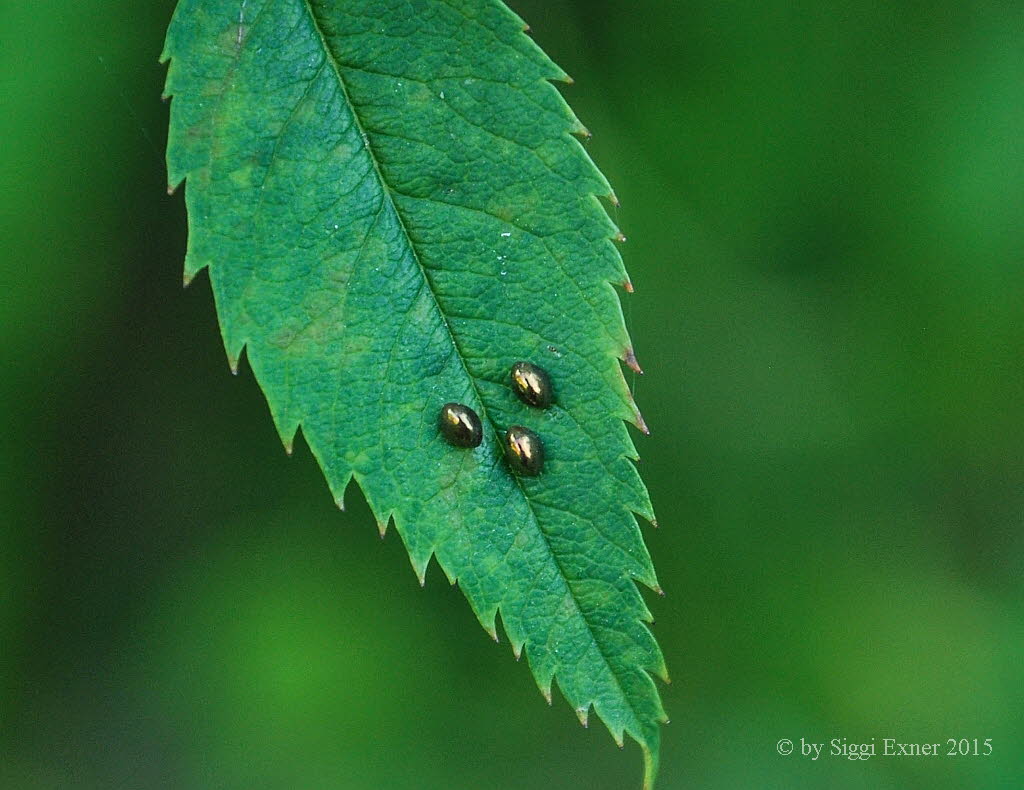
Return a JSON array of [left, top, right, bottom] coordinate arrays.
[[164, 0, 666, 786]]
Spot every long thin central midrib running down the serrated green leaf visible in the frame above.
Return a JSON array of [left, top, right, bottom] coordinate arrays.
[[299, 0, 646, 741]]
